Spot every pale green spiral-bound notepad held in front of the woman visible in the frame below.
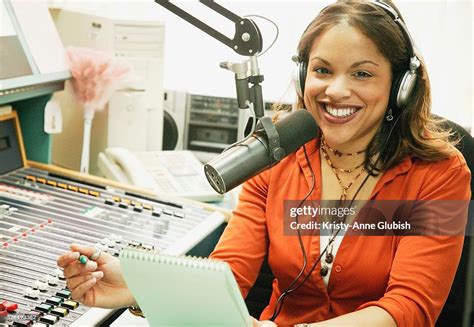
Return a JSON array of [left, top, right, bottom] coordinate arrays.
[[120, 249, 252, 327]]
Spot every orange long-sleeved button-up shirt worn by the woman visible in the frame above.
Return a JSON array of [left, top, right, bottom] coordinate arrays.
[[211, 140, 471, 327]]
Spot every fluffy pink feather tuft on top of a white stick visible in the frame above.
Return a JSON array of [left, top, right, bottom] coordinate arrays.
[[66, 47, 131, 110]]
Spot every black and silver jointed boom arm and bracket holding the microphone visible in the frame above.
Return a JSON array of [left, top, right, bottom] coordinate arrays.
[[155, 0, 285, 165]]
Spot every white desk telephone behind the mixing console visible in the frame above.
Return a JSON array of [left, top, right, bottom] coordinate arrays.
[[97, 147, 223, 202]]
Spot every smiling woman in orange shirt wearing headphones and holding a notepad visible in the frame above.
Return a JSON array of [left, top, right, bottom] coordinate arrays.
[[55, 0, 471, 327]]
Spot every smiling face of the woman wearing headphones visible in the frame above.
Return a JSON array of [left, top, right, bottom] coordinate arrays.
[[304, 23, 392, 152]]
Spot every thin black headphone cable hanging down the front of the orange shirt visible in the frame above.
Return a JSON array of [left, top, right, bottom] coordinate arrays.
[[269, 115, 401, 321]]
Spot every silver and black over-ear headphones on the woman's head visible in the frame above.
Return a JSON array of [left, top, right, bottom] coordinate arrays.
[[292, 0, 420, 110]]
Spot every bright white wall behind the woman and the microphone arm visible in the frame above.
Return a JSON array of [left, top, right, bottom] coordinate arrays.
[[50, 0, 474, 126]]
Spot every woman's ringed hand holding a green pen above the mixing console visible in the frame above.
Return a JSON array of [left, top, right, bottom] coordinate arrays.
[[57, 244, 136, 308]]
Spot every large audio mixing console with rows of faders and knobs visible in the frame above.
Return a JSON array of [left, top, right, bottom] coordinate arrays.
[[0, 168, 224, 326]]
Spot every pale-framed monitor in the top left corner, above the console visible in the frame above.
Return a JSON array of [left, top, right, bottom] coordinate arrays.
[[0, 0, 70, 105]]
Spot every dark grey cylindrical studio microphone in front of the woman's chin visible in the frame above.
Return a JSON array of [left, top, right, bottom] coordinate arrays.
[[204, 109, 318, 194]]
